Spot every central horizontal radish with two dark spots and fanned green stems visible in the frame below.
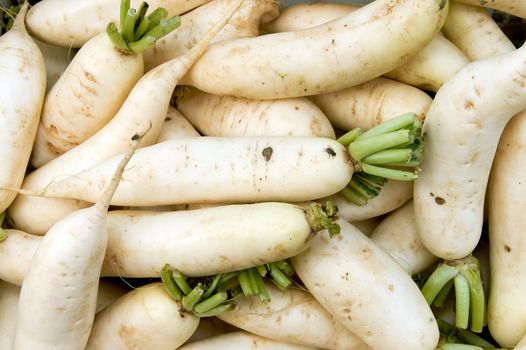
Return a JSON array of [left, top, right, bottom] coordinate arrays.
[[19, 113, 422, 206]]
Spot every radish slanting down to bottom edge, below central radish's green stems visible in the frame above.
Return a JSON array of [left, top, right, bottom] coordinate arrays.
[[290, 220, 439, 350]]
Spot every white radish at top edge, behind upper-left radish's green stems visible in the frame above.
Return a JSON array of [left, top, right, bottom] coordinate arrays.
[[26, 0, 210, 47]]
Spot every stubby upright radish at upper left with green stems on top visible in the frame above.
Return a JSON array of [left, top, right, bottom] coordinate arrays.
[[31, 0, 185, 168]]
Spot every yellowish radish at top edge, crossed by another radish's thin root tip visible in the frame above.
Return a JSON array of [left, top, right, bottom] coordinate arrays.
[[144, 0, 279, 71]]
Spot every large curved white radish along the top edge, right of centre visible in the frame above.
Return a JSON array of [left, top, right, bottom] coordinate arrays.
[[182, 0, 448, 99]]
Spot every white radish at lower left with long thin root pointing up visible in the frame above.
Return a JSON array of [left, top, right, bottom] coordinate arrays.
[[13, 134, 140, 350]]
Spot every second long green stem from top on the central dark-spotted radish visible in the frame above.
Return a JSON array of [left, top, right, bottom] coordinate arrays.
[[348, 129, 412, 161]]
